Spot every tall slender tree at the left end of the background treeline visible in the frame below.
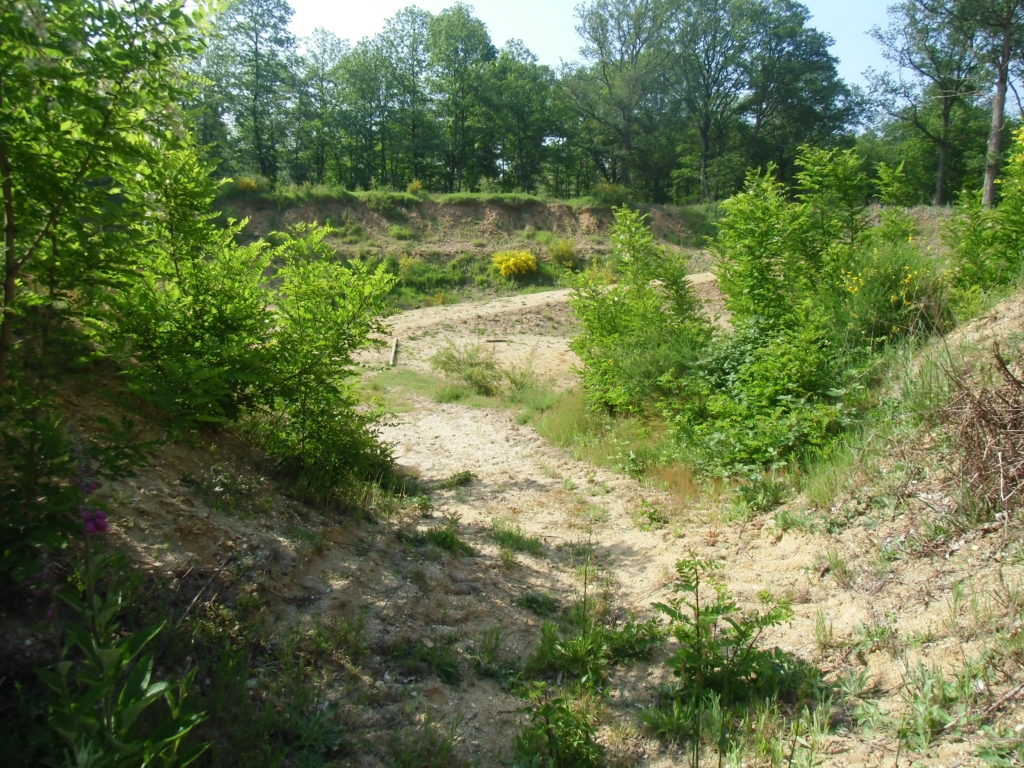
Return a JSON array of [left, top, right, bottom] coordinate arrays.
[[217, 0, 295, 184]]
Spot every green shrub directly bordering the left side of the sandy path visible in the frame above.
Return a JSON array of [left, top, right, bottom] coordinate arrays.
[[249, 227, 394, 489]]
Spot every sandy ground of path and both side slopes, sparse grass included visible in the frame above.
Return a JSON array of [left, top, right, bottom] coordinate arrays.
[[22, 286, 1024, 768]]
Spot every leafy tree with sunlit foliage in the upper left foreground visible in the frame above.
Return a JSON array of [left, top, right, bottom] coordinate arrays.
[[0, 0, 202, 387]]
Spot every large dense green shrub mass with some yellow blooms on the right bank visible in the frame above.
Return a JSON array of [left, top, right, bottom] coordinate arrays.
[[665, 143, 950, 472]]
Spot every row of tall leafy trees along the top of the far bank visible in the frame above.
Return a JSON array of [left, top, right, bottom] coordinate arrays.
[[193, 0, 1024, 204]]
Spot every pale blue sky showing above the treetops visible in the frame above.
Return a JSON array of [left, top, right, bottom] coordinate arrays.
[[290, 0, 894, 85]]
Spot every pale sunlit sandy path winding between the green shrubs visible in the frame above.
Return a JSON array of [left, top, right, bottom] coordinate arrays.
[[368, 272, 715, 610]]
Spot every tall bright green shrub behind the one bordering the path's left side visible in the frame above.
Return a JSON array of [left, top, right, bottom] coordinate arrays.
[[105, 150, 271, 426]]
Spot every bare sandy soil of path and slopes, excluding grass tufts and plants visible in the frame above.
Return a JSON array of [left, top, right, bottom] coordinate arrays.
[[80, 274, 1024, 768]]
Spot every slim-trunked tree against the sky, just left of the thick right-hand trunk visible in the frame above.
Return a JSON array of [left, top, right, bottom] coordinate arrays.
[[871, 0, 981, 205]]
